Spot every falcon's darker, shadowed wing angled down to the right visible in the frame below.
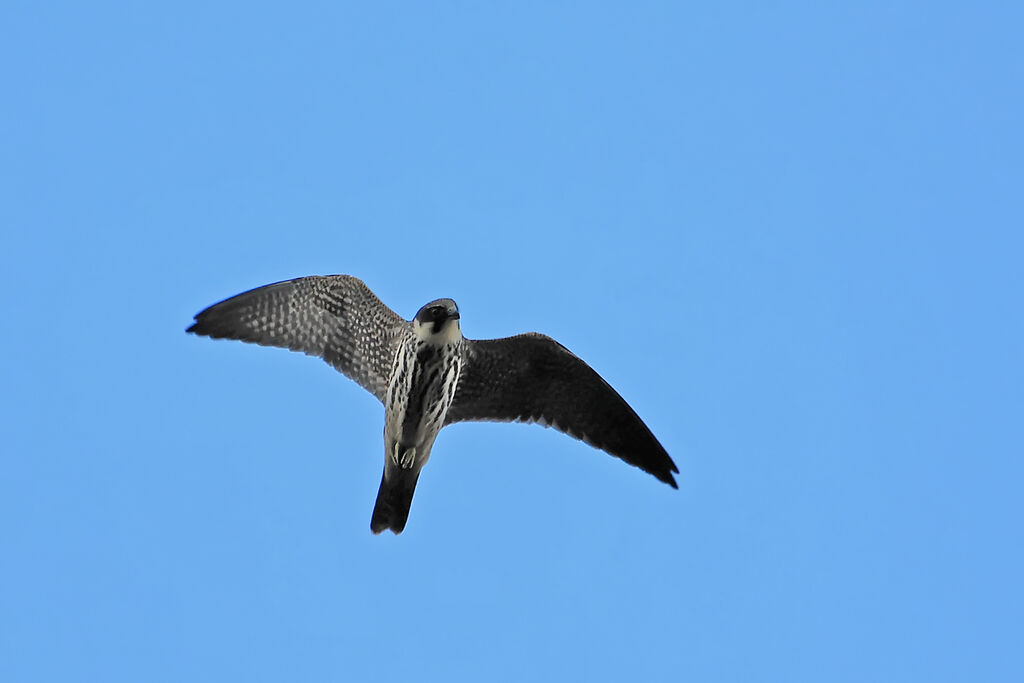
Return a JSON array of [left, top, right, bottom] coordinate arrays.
[[445, 333, 679, 488]]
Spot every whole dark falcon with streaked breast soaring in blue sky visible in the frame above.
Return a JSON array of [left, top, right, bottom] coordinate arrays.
[[186, 275, 679, 533]]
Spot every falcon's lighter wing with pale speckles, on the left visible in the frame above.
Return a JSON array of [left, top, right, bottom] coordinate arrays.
[[186, 275, 409, 401]]
